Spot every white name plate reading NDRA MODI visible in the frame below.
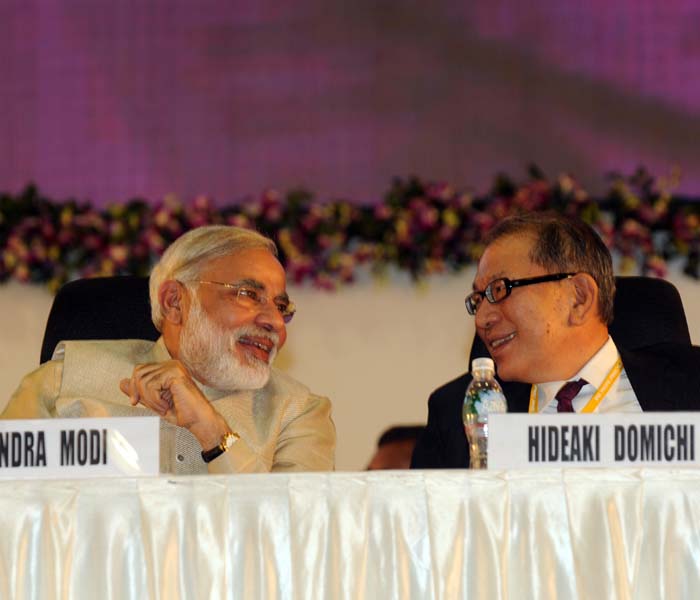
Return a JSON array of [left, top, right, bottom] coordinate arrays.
[[0, 417, 160, 479]]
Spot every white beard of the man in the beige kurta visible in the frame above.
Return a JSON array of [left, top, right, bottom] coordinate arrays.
[[180, 297, 279, 392]]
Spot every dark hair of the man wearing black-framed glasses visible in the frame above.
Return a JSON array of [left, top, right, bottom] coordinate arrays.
[[484, 211, 615, 325]]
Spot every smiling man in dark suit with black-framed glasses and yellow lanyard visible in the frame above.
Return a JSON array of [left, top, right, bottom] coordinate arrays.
[[411, 213, 700, 468]]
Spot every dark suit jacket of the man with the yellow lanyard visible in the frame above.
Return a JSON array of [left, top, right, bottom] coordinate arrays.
[[411, 343, 700, 469]]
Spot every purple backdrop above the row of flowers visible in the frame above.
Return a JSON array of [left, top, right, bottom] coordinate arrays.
[[0, 0, 700, 203]]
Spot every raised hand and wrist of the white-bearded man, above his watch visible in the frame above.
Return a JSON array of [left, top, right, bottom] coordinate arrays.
[[119, 360, 229, 450]]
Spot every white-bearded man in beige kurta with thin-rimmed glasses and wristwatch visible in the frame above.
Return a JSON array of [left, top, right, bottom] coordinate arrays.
[[2, 227, 335, 474]]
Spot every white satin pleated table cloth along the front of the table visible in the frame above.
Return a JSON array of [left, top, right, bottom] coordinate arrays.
[[0, 469, 700, 600]]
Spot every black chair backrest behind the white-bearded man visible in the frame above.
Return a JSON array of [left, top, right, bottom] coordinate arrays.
[[40, 276, 160, 363]]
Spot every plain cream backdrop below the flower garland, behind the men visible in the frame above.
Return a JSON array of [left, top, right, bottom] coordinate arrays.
[[0, 269, 700, 470]]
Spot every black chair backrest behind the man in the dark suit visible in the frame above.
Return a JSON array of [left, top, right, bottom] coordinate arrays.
[[469, 277, 691, 365]]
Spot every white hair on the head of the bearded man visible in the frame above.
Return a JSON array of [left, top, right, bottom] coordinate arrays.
[[149, 225, 277, 331]]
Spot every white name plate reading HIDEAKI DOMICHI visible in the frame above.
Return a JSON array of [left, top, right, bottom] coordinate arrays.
[[488, 412, 700, 469]]
